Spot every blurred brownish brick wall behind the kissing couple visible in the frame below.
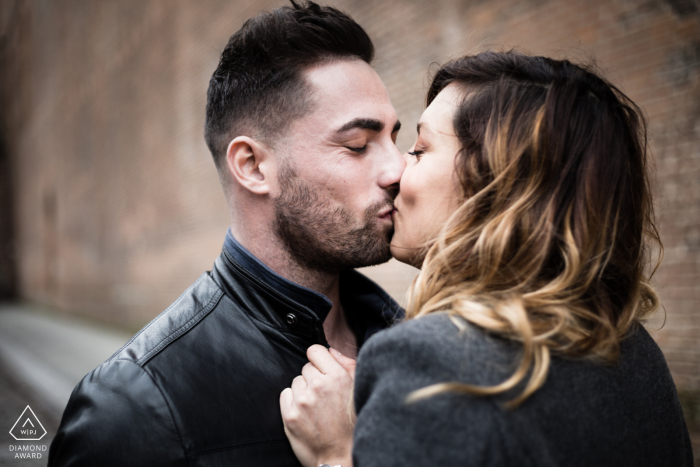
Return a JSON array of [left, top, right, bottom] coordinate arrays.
[[0, 0, 700, 390]]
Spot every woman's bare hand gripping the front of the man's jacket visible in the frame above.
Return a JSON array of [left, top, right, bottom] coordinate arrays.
[[280, 345, 355, 467]]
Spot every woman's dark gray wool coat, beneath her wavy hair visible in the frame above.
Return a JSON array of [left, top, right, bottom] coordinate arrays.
[[353, 313, 693, 467]]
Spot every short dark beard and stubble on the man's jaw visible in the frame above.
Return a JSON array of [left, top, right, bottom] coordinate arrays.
[[275, 166, 393, 272]]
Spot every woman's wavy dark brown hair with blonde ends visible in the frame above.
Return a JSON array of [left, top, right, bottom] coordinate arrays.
[[407, 51, 663, 407]]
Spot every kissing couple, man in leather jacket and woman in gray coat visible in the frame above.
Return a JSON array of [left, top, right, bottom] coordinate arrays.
[[49, 1, 693, 467]]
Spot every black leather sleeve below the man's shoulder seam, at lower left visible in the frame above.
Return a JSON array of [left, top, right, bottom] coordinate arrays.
[[49, 360, 185, 467]]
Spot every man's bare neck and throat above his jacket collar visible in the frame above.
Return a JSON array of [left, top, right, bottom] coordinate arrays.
[[231, 227, 357, 358]]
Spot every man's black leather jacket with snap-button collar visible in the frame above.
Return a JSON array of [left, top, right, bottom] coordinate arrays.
[[49, 250, 402, 467]]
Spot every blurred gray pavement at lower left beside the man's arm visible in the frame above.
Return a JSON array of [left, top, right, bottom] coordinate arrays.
[[0, 304, 130, 467]]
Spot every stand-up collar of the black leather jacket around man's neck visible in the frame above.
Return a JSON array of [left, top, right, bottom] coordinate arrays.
[[216, 229, 404, 347]]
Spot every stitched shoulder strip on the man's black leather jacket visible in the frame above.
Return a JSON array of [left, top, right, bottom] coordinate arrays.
[[105, 273, 224, 366]]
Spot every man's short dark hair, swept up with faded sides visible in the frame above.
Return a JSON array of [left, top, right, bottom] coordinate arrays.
[[204, 0, 374, 176]]
